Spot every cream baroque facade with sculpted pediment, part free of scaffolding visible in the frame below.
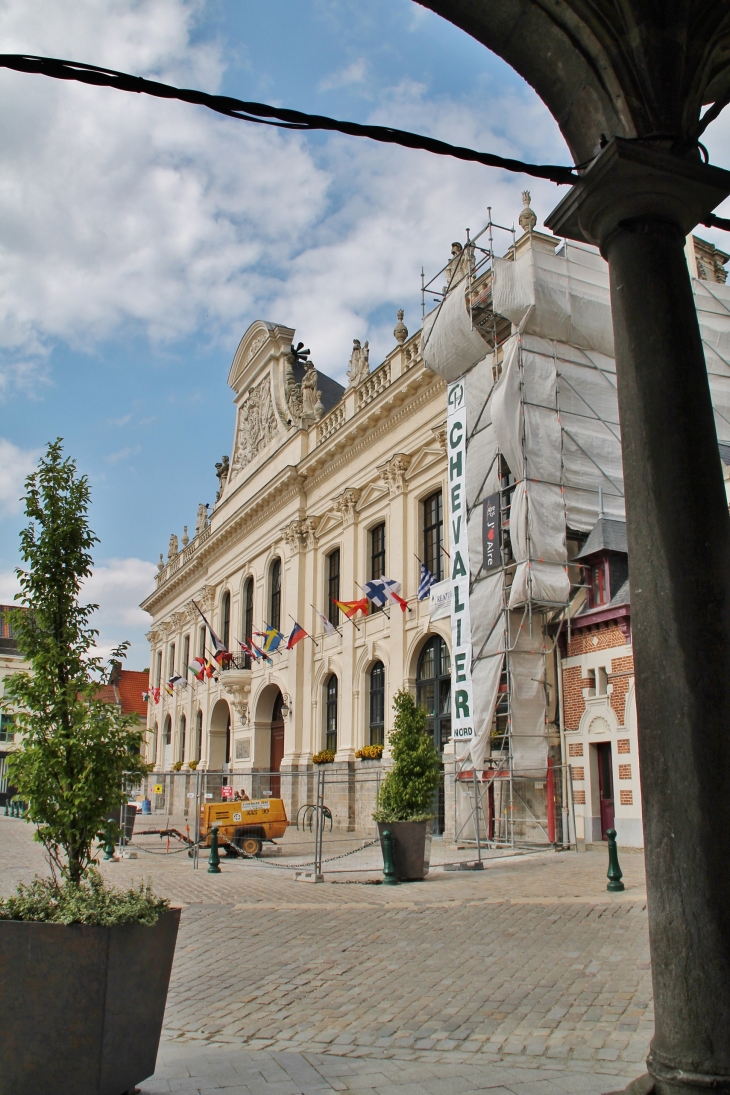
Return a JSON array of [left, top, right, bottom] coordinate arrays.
[[142, 313, 450, 814]]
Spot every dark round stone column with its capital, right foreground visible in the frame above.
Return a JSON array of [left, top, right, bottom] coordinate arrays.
[[549, 141, 730, 1095]]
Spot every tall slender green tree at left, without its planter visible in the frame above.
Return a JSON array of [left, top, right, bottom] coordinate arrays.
[[2, 438, 149, 885]]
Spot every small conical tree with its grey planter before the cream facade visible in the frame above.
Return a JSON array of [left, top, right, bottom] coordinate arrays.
[[373, 689, 440, 881]]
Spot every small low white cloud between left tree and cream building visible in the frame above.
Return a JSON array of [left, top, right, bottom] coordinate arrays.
[[82, 558, 157, 669]]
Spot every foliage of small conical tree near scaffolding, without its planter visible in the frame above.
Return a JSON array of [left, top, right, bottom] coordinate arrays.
[[373, 689, 441, 821]]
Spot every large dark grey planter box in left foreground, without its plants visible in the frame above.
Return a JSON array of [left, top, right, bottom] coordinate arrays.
[[0, 909, 179, 1095]]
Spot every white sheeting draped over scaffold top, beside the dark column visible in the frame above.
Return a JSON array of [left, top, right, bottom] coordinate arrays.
[[493, 241, 613, 356]]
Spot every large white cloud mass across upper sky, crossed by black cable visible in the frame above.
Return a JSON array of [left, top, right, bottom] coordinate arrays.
[[0, 0, 568, 391]]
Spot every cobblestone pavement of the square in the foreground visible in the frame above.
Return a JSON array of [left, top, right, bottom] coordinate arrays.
[[0, 818, 653, 1095]]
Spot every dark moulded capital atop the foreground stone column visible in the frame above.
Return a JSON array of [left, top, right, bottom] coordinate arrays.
[[545, 137, 730, 247]]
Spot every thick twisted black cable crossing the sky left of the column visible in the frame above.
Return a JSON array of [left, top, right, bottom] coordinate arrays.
[[0, 54, 580, 185]]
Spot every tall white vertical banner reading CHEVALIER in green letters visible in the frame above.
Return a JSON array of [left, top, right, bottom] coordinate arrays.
[[447, 379, 474, 741]]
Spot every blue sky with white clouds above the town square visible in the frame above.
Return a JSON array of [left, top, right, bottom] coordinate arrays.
[[0, 0, 730, 669]]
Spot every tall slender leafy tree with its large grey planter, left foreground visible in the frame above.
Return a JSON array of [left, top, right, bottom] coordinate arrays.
[[0, 440, 179, 1095]]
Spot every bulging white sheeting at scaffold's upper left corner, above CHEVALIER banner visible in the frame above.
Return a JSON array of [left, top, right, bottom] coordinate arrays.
[[420, 283, 489, 382]]
